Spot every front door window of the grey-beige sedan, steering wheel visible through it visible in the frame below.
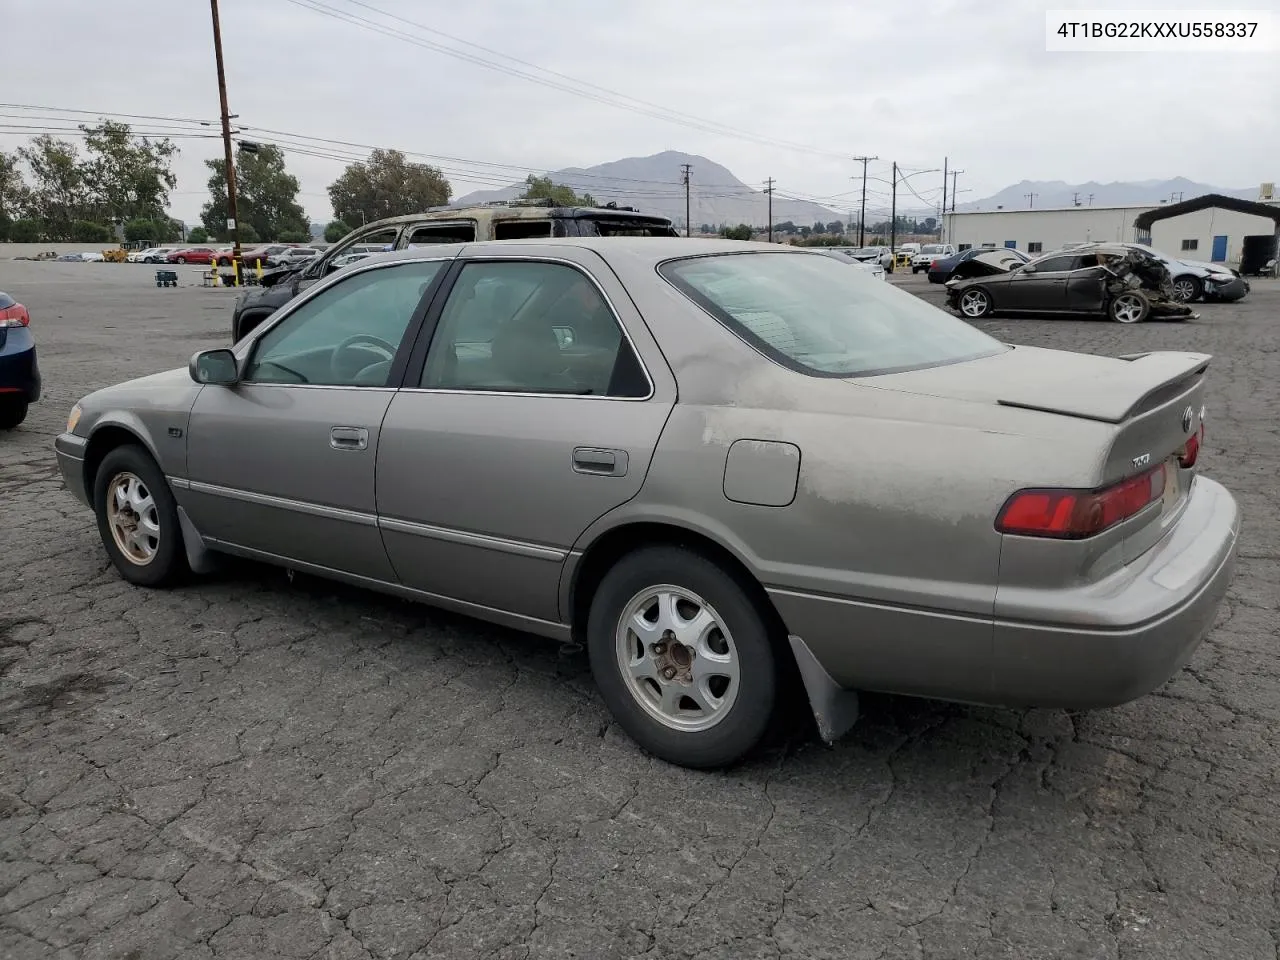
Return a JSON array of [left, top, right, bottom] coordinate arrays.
[[244, 261, 444, 387]]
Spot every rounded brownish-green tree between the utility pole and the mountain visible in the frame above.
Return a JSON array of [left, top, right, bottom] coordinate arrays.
[[329, 150, 453, 224]]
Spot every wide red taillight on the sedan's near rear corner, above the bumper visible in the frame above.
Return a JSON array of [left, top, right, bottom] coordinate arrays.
[[996, 463, 1165, 540]]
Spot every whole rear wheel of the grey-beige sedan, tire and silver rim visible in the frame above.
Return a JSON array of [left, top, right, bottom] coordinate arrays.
[[588, 547, 777, 769]]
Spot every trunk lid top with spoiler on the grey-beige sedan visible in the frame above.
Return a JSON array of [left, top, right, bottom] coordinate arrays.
[[859, 347, 1211, 424]]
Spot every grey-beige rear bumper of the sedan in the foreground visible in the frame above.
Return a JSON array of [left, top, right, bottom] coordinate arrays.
[[768, 476, 1240, 709]]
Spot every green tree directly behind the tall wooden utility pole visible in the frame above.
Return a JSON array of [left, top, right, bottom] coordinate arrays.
[[200, 143, 310, 241]]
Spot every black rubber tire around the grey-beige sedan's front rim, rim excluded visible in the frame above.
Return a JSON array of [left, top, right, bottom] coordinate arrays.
[[93, 444, 189, 588]]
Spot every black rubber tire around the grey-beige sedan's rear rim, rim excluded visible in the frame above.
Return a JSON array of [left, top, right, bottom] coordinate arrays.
[[586, 547, 778, 769]]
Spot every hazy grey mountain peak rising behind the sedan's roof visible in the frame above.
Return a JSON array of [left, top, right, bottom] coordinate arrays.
[[453, 150, 849, 229]]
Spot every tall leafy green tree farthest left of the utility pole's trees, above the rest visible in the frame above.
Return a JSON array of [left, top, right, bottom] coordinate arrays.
[[81, 120, 178, 221]]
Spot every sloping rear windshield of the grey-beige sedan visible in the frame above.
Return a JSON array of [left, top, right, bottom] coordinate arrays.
[[659, 252, 1007, 376]]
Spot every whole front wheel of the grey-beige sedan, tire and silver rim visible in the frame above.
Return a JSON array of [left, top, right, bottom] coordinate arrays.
[[93, 444, 187, 586]]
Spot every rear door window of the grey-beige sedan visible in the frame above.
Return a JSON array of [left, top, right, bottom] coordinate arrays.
[[419, 261, 649, 398]]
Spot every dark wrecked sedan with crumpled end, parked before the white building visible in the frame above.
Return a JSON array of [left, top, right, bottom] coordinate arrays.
[[946, 243, 1198, 324]]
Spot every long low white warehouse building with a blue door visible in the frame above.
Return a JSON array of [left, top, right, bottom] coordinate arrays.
[[945, 183, 1280, 271]]
